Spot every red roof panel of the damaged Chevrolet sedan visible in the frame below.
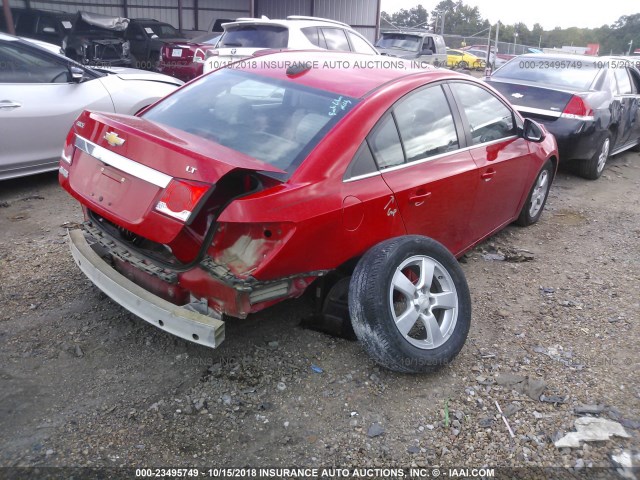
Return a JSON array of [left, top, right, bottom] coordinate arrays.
[[231, 50, 469, 98]]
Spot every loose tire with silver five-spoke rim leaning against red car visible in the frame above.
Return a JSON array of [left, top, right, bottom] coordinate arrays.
[[349, 235, 471, 373]]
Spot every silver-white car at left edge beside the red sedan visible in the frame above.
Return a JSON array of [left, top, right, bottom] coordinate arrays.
[[0, 33, 183, 180]]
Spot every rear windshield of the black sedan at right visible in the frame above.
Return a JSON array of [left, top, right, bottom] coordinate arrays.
[[492, 57, 599, 90]]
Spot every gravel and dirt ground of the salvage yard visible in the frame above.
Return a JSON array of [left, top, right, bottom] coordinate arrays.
[[0, 153, 640, 469]]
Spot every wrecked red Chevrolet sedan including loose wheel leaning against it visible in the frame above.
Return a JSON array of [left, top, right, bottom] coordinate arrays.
[[59, 52, 558, 372]]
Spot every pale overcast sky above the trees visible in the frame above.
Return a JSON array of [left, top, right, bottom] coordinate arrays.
[[382, 0, 640, 29]]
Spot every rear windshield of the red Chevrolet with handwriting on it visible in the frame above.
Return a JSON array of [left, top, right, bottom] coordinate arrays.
[[142, 69, 357, 173]]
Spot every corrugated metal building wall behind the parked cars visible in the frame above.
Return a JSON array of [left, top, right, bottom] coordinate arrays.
[[9, 0, 380, 42]]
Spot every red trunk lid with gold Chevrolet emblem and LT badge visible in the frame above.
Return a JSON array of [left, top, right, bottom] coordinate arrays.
[[68, 111, 282, 244]]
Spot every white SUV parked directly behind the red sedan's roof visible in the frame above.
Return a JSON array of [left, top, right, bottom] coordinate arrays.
[[203, 15, 379, 73]]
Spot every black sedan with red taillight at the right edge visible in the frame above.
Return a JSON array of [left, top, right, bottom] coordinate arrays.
[[488, 54, 640, 180]]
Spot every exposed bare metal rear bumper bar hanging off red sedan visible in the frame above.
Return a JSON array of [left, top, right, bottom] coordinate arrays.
[[69, 230, 224, 348]]
